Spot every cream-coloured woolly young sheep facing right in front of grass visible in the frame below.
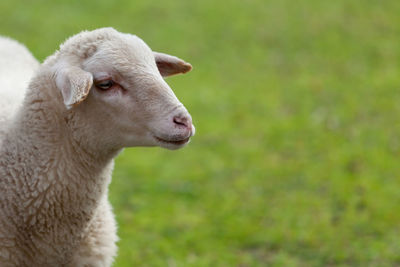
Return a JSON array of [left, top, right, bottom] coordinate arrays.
[[0, 28, 195, 266]]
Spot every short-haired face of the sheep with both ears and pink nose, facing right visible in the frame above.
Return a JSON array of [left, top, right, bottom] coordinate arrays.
[[56, 29, 195, 152]]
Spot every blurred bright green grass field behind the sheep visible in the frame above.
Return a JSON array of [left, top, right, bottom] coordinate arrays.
[[0, 0, 400, 266]]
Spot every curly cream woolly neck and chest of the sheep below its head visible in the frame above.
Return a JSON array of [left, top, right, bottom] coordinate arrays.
[[0, 66, 118, 267]]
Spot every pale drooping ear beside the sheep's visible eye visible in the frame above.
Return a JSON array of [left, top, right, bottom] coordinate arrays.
[[56, 66, 93, 109]]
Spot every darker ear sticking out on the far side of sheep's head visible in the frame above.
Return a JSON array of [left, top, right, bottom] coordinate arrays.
[[153, 52, 192, 77]]
